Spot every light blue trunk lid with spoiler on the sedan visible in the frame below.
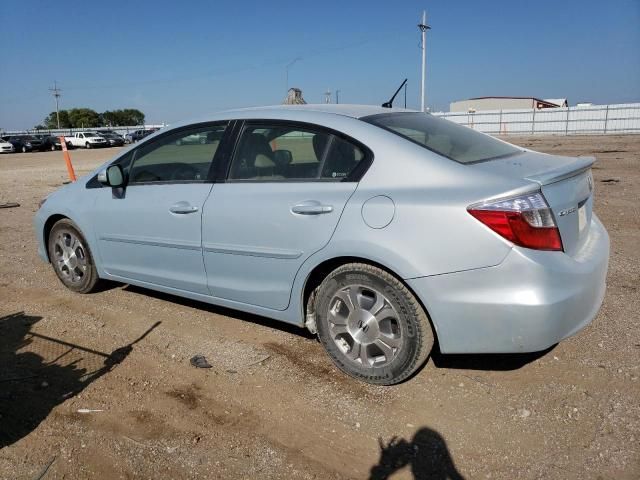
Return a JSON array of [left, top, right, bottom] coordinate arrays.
[[473, 151, 595, 256]]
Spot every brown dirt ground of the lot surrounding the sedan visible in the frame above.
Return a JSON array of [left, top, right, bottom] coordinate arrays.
[[0, 135, 640, 479]]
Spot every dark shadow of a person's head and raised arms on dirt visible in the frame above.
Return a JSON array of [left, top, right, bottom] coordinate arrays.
[[369, 427, 464, 480]]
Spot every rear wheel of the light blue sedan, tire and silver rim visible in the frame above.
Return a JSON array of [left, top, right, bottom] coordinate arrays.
[[315, 263, 434, 385]]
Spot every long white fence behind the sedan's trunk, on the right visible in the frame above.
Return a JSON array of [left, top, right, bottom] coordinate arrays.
[[434, 103, 640, 135]]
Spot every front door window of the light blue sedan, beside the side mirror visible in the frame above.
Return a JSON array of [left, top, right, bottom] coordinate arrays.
[[129, 125, 226, 183]]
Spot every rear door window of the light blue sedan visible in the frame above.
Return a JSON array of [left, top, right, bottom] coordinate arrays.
[[229, 125, 365, 181]]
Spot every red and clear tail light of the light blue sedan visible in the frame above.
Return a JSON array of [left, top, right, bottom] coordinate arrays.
[[467, 192, 562, 251]]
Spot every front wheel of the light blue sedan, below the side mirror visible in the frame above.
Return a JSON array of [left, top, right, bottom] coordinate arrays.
[[47, 218, 100, 293]]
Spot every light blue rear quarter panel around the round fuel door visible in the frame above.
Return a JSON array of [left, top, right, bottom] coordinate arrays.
[[310, 122, 535, 279]]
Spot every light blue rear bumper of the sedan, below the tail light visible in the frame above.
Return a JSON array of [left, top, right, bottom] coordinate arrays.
[[407, 215, 609, 353]]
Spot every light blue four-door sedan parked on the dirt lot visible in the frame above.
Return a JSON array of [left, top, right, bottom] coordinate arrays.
[[35, 105, 609, 385]]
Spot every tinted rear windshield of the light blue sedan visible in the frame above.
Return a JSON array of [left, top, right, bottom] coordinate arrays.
[[362, 112, 522, 163]]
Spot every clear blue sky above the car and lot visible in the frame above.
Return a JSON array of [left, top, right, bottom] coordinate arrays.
[[0, 0, 640, 129]]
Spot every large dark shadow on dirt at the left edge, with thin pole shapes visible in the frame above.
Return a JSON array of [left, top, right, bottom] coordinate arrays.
[[0, 312, 160, 449]]
